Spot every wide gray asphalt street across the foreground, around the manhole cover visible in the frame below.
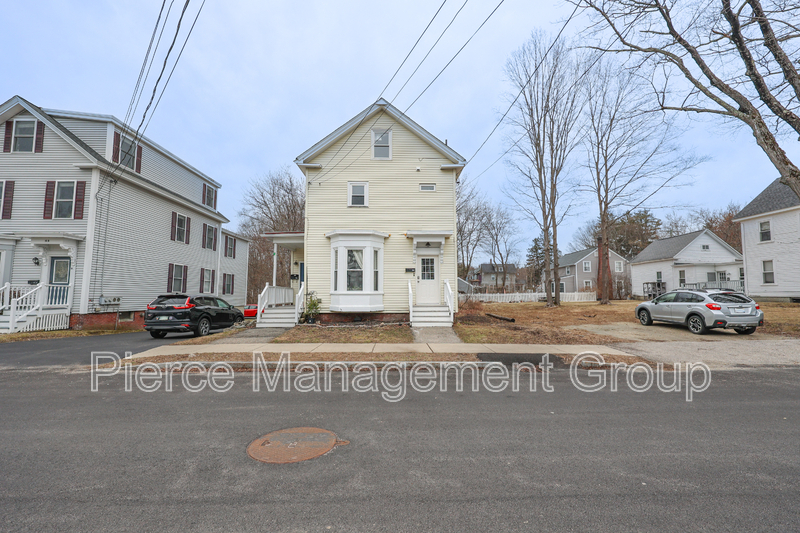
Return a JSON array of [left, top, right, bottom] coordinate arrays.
[[0, 369, 800, 533]]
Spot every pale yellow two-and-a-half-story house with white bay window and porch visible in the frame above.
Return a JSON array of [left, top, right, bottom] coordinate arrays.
[[258, 99, 466, 327]]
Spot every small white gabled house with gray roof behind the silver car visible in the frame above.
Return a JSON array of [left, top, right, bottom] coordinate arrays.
[[631, 229, 744, 298]]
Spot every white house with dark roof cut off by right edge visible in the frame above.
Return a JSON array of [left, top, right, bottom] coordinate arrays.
[[734, 179, 800, 301]]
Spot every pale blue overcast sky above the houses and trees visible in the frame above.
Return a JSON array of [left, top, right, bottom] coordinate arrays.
[[0, 0, 797, 258]]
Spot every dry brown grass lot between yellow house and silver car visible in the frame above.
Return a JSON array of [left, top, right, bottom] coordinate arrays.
[[453, 301, 638, 344]]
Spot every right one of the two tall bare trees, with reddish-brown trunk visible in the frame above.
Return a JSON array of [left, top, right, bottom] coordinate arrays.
[[582, 59, 701, 304]]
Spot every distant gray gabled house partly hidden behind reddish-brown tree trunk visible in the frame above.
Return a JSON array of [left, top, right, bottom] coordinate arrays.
[[551, 247, 630, 299]]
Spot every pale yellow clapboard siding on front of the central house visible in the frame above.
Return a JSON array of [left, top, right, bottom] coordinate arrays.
[[305, 115, 457, 313]]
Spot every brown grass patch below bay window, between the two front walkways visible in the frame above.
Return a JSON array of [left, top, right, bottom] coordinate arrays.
[[272, 324, 414, 344]]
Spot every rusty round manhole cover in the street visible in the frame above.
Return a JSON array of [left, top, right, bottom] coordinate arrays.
[[247, 428, 350, 464]]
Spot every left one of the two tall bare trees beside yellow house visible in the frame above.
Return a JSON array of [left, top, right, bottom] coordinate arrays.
[[505, 32, 585, 306]]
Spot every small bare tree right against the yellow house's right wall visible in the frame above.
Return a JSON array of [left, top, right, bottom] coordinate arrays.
[[456, 176, 489, 279]]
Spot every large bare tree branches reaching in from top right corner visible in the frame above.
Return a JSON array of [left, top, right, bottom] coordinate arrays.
[[571, 0, 800, 196]]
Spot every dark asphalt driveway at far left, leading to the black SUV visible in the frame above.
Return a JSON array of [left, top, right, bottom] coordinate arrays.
[[0, 331, 192, 368]]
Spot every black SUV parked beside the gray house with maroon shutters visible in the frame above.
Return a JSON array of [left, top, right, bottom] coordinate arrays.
[[144, 294, 244, 339]]
